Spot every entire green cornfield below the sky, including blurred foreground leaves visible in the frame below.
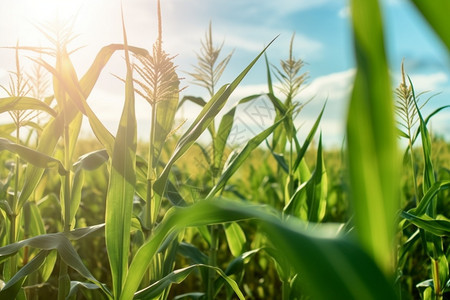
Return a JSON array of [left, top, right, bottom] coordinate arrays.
[[0, 0, 450, 299]]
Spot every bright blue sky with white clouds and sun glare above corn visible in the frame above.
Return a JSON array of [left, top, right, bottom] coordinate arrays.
[[0, 0, 450, 147]]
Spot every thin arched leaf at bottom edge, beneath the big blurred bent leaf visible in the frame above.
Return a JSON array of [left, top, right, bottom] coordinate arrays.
[[133, 264, 245, 300]]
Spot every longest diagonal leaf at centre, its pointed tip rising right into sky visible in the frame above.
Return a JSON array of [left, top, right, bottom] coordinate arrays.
[[154, 41, 273, 195]]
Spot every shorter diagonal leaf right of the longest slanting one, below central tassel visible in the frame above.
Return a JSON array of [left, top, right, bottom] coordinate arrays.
[[206, 119, 283, 199]]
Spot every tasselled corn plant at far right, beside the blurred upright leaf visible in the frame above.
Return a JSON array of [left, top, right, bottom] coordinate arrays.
[[397, 69, 449, 299]]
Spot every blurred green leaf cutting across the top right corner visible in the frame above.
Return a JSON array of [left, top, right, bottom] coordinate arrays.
[[411, 0, 450, 51]]
